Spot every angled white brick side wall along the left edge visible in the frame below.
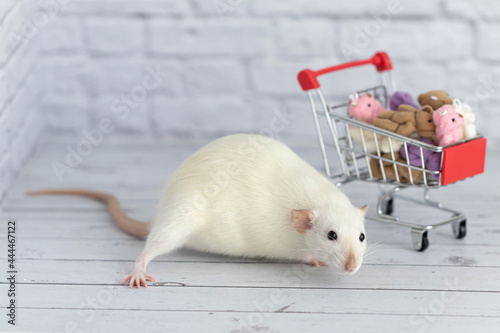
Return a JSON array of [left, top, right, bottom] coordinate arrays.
[[0, 0, 48, 203]]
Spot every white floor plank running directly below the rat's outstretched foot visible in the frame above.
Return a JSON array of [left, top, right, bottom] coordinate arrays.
[[0, 284, 500, 317]]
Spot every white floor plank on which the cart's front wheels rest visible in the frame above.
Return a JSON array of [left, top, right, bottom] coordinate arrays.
[[0, 210, 500, 248]]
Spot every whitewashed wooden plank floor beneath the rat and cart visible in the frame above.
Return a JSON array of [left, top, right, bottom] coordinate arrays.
[[0, 137, 500, 332]]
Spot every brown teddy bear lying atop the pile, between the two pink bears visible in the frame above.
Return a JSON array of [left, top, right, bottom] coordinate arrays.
[[373, 104, 436, 138]]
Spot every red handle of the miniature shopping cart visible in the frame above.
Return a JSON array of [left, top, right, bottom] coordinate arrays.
[[297, 52, 392, 91]]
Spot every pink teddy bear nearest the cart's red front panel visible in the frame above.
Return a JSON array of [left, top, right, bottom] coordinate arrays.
[[432, 104, 464, 147]]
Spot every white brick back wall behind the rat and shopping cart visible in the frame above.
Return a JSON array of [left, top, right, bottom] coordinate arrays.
[[0, 0, 500, 201]]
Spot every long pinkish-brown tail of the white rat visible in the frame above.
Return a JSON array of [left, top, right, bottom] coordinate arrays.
[[26, 190, 149, 238]]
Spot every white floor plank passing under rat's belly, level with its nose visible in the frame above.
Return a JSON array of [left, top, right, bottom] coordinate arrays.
[[0, 236, 500, 267]]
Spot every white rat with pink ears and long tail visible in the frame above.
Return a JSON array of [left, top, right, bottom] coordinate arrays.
[[28, 134, 366, 288]]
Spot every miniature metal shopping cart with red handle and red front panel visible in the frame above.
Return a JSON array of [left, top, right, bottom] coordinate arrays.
[[298, 52, 486, 251]]
